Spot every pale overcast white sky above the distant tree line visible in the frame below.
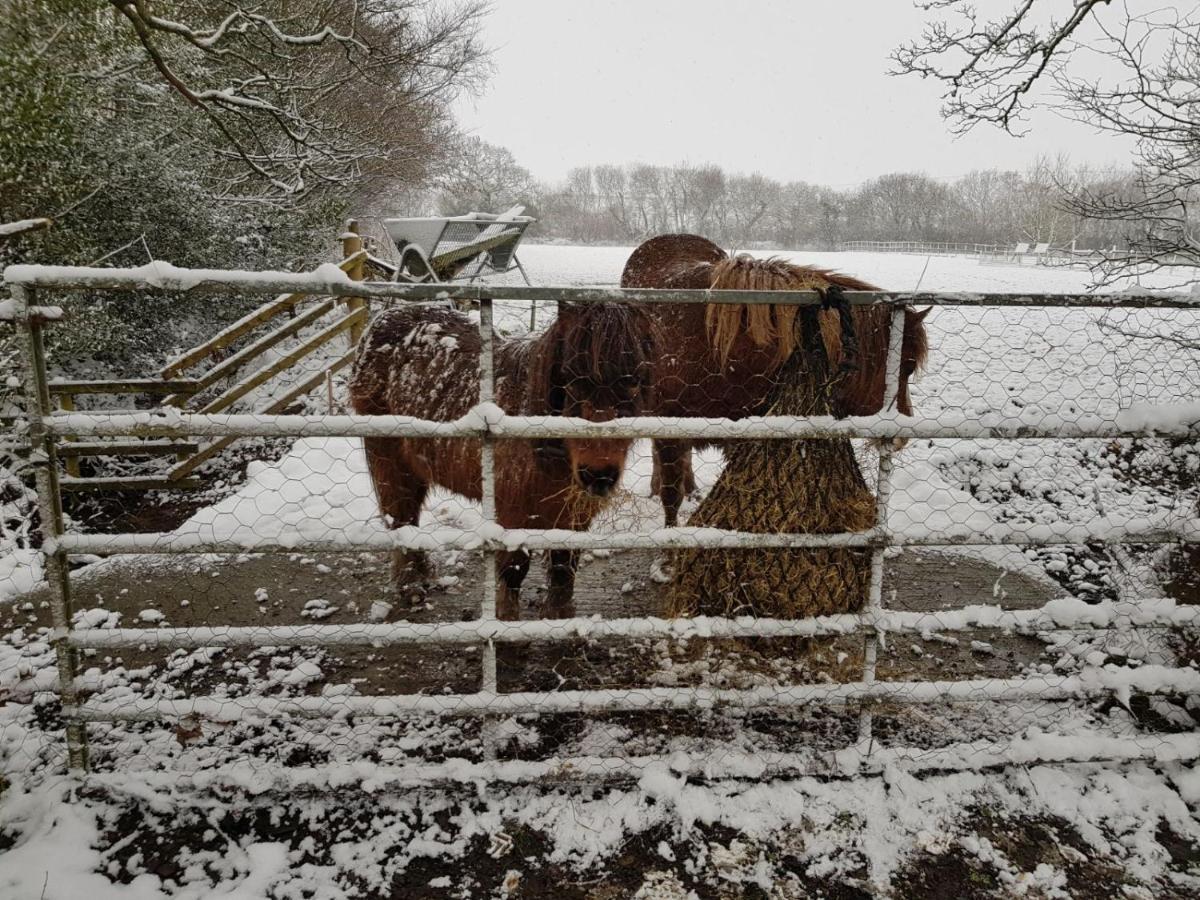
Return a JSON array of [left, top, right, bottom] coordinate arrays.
[[456, 0, 1128, 186]]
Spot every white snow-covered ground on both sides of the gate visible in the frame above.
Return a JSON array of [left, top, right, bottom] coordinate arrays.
[[0, 245, 1200, 900]]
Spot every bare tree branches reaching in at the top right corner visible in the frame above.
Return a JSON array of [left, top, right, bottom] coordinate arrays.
[[893, 0, 1200, 281]]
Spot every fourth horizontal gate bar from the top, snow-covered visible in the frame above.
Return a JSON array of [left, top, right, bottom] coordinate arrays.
[[66, 598, 1200, 649]]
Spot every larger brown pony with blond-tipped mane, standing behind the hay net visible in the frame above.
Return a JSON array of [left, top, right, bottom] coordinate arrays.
[[620, 234, 929, 526]]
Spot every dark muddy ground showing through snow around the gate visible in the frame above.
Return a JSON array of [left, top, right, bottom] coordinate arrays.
[[11, 551, 1200, 900]]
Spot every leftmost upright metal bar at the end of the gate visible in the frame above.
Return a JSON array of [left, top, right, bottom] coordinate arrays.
[[12, 284, 88, 772]]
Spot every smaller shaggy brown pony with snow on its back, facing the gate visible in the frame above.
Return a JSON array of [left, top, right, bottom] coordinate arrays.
[[350, 304, 654, 619]]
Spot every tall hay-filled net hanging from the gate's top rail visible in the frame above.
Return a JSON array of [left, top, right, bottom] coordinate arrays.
[[666, 311, 875, 618]]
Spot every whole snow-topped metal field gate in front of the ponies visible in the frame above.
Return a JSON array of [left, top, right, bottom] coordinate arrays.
[[5, 265, 1200, 785]]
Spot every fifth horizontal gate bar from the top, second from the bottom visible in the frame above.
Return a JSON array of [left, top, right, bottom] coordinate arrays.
[[72, 666, 1200, 722]]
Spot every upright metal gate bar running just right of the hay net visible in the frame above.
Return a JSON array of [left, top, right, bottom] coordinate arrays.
[[858, 305, 905, 754]]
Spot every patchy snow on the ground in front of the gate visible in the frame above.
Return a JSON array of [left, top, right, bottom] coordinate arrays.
[[0, 766, 1195, 900]]
